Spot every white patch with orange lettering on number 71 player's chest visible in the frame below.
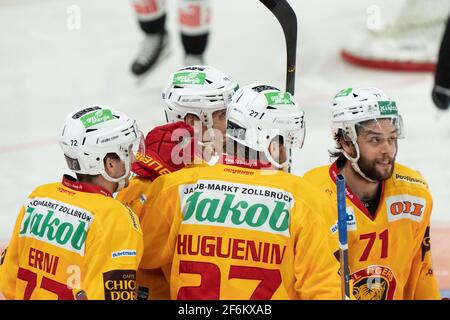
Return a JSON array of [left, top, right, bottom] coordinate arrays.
[[386, 194, 427, 222]]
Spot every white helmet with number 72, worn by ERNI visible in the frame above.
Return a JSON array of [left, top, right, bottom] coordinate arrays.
[[59, 106, 145, 189]]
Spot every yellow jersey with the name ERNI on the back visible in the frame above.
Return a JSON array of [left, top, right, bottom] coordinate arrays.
[[0, 176, 143, 300]]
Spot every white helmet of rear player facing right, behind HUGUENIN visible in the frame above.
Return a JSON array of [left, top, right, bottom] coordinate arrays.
[[162, 65, 239, 129]]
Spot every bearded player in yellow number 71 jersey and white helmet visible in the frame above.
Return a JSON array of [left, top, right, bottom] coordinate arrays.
[[304, 88, 440, 300]]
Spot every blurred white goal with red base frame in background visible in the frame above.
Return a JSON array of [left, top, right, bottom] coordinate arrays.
[[341, 0, 450, 71]]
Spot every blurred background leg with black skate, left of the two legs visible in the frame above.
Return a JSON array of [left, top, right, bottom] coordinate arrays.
[[131, 0, 169, 76]]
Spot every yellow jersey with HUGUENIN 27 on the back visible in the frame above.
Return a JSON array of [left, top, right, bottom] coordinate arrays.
[[140, 164, 340, 300]]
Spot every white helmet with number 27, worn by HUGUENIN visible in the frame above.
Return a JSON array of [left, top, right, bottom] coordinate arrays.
[[227, 83, 305, 168]]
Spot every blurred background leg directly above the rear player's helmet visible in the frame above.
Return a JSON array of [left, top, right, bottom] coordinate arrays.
[[178, 0, 211, 66]]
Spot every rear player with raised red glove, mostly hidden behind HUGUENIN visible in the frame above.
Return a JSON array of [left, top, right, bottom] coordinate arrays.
[[116, 66, 238, 299]]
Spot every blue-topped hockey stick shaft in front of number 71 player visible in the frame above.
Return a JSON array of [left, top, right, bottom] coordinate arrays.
[[336, 174, 350, 300]]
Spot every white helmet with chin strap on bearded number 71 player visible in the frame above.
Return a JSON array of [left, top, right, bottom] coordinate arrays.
[[331, 88, 403, 182]]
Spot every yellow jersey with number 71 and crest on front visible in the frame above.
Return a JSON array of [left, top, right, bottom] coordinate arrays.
[[304, 163, 440, 300]]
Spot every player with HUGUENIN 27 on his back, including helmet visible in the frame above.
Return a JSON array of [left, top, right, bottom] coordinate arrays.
[[140, 84, 340, 299]]
